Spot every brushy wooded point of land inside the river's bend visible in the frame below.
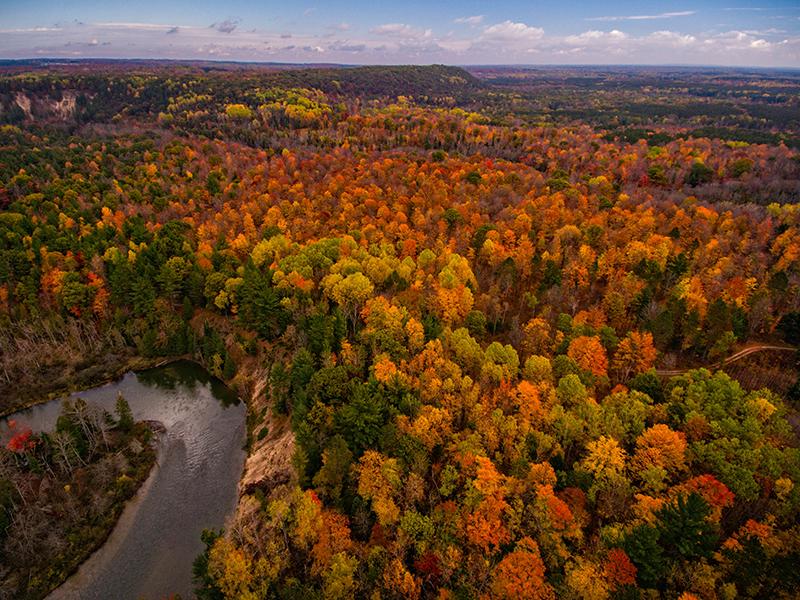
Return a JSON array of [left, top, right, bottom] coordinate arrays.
[[0, 412, 159, 599]]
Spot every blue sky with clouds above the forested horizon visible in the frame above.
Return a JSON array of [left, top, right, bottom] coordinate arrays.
[[0, 0, 800, 68]]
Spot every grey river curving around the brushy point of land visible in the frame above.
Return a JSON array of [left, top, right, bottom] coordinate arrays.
[[0, 361, 245, 600]]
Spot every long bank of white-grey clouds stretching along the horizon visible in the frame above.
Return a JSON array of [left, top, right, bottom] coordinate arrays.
[[0, 16, 800, 66]]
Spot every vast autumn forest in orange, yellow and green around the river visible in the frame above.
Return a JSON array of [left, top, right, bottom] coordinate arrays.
[[0, 61, 800, 600]]
